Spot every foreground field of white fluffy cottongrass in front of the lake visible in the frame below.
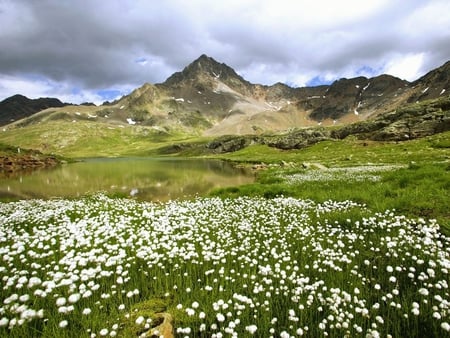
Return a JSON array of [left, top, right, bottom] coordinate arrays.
[[0, 194, 450, 337]]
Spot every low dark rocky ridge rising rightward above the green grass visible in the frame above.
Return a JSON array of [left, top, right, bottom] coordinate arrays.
[[161, 97, 450, 154]]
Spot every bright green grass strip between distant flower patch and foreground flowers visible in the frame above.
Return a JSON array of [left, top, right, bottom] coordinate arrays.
[[211, 164, 450, 235]]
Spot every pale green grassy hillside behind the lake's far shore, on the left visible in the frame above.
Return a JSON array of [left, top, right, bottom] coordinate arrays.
[[0, 121, 211, 158]]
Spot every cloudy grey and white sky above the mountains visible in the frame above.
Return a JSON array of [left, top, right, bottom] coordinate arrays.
[[0, 0, 450, 104]]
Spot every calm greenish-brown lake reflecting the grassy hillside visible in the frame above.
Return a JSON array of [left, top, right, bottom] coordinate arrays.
[[0, 158, 254, 201]]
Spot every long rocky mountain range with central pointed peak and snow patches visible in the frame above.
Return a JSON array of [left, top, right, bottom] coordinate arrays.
[[2, 55, 450, 136]]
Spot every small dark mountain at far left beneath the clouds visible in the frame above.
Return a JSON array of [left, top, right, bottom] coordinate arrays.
[[0, 94, 67, 125]]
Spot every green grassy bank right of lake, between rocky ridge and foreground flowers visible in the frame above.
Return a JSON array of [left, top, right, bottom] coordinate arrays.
[[212, 132, 450, 234]]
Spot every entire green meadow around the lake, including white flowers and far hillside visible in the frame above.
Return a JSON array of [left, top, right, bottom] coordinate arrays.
[[0, 123, 450, 337]]
